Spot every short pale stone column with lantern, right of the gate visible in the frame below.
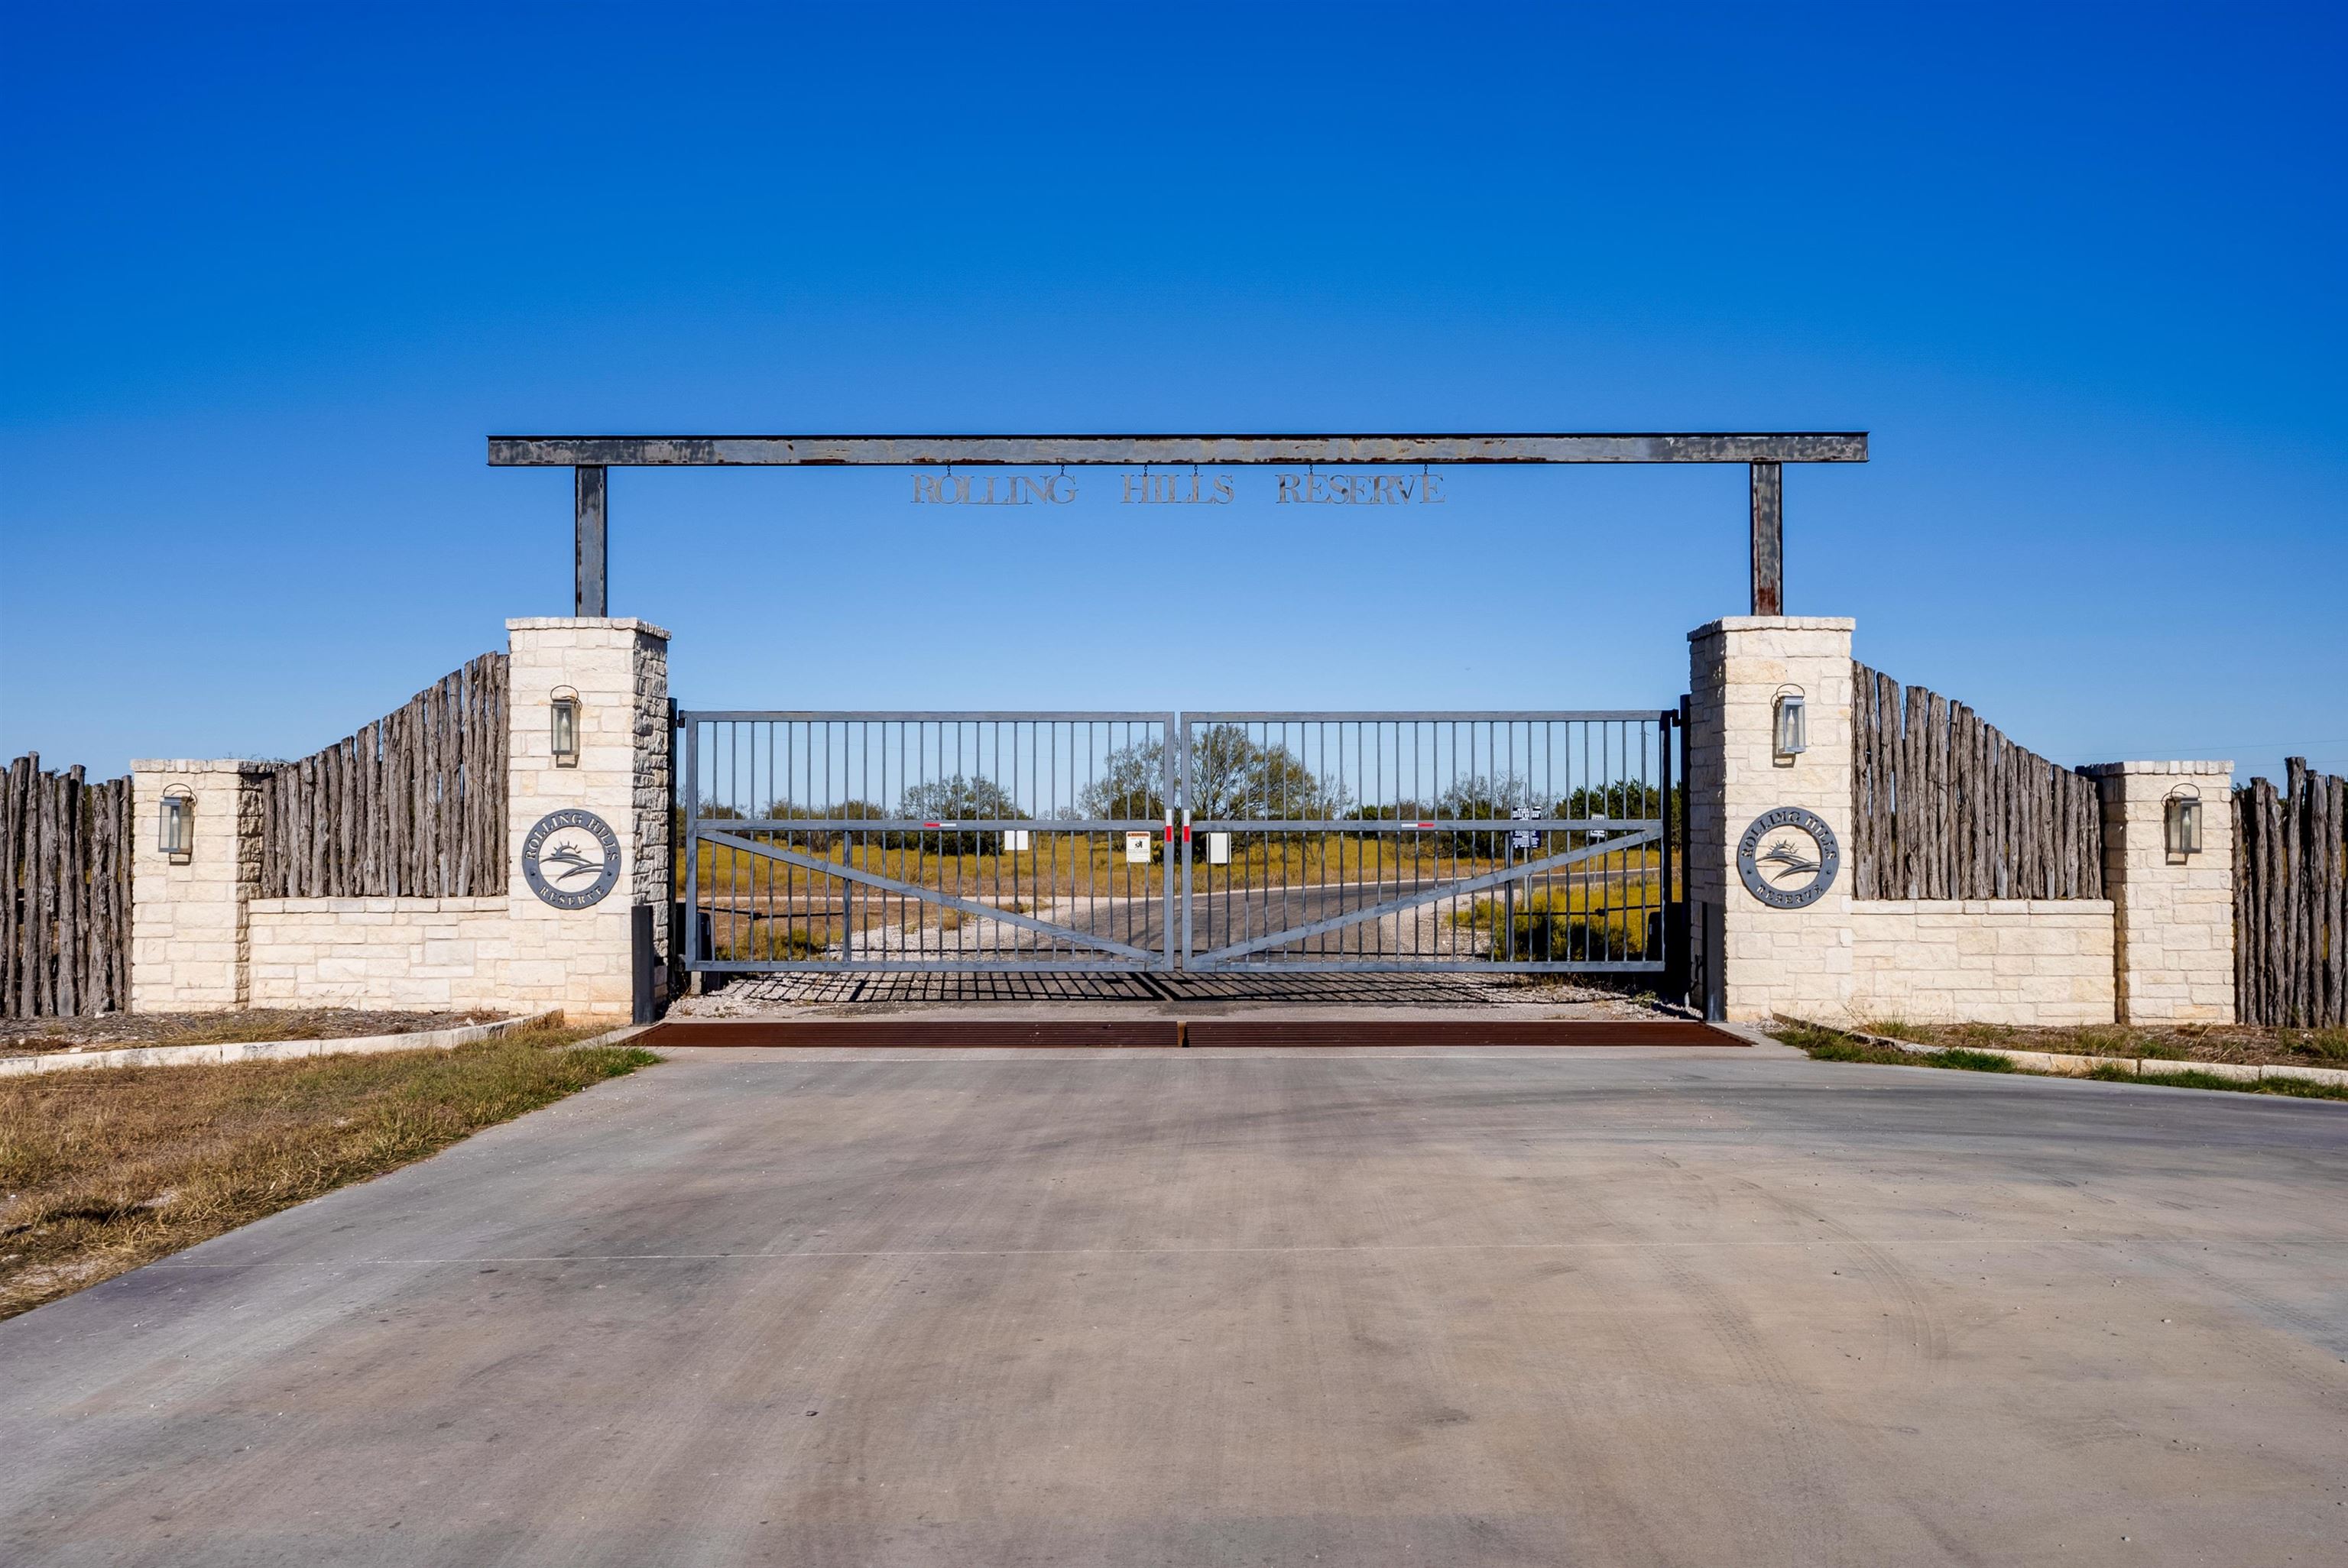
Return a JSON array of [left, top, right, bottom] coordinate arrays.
[[2080, 763, 2236, 1023]]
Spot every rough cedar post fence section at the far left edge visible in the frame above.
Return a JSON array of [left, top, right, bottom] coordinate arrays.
[[0, 751, 131, 1019]]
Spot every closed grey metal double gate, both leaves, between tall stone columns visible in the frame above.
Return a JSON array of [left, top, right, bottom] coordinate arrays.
[[679, 709, 1684, 974]]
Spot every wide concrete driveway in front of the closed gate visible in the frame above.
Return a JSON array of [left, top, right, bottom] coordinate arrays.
[[0, 1032, 2348, 1568]]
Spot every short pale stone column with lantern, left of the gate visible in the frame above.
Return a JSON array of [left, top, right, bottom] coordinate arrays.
[[131, 758, 270, 1012]]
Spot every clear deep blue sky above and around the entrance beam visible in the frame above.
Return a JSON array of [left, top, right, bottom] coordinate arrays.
[[0, 2, 2348, 775]]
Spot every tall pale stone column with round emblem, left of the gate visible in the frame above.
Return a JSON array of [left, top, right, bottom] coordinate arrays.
[[504, 617, 670, 1023]]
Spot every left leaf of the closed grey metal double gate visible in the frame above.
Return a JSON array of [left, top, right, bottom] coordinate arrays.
[[679, 711, 1179, 974]]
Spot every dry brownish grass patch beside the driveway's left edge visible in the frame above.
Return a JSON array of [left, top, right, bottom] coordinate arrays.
[[0, 1028, 657, 1317]]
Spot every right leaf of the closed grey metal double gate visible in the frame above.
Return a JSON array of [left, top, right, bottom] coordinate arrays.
[[1181, 709, 1676, 974]]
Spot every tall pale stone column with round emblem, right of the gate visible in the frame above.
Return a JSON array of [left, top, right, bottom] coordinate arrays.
[[1686, 615, 1855, 1021]]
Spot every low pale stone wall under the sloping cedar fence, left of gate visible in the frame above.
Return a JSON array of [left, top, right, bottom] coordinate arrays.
[[251, 896, 512, 1012]]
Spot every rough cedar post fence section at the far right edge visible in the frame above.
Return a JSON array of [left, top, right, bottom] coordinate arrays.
[[2233, 756, 2348, 1028]]
